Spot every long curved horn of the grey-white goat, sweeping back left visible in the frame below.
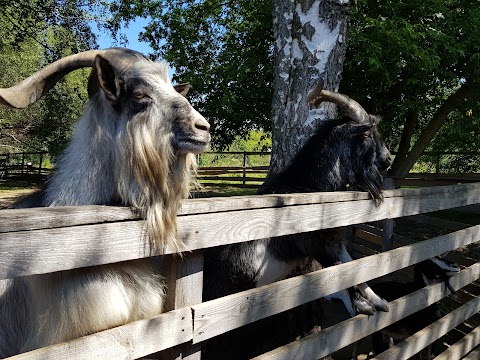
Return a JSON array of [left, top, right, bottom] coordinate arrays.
[[0, 48, 143, 109]]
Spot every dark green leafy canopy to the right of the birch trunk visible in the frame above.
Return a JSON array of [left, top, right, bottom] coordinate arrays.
[[342, 0, 480, 150]]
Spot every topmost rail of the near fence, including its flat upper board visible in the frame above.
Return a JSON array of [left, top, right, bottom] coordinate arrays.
[[0, 184, 480, 279]]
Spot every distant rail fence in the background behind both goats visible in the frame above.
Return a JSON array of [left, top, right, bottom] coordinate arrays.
[[0, 151, 480, 188]]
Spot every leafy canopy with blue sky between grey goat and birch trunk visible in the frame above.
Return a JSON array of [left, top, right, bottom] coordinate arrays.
[[111, 0, 273, 149]]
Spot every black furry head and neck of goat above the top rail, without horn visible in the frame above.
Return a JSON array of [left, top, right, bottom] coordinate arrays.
[[258, 116, 391, 200]]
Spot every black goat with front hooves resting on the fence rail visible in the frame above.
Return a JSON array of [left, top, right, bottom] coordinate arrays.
[[204, 83, 391, 359]]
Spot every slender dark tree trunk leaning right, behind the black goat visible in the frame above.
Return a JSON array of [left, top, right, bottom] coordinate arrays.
[[390, 83, 473, 177]]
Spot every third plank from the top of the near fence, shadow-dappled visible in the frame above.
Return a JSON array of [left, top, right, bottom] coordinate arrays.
[[251, 264, 480, 360]]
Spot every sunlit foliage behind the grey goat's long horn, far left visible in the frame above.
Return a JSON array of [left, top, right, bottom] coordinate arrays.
[[0, 0, 103, 154]]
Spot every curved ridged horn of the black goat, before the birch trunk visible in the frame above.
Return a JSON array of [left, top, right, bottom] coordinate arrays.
[[308, 80, 369, 124]]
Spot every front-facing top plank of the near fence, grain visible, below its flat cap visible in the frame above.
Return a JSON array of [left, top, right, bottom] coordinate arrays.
[[0, 184, 480, 279]]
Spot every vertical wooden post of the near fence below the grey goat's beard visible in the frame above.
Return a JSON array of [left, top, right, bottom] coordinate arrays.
[[159, 250, 203, 360]]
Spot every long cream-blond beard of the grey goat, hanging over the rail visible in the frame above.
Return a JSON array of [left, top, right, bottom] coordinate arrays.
[[117, 117, 196, 254]]
